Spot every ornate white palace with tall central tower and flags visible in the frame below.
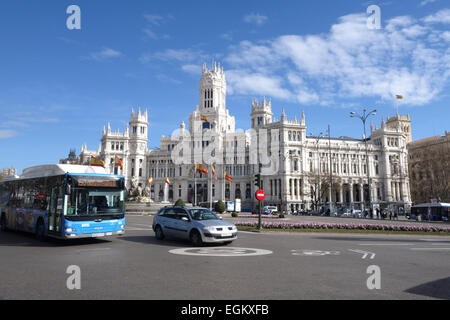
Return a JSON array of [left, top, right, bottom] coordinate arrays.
[[65, 64, 411, 210]]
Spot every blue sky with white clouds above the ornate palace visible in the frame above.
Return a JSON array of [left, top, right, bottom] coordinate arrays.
[[0, 0, 450, 173]]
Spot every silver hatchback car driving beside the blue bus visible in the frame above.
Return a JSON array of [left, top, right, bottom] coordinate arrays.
[[152, 207, 237, 246]]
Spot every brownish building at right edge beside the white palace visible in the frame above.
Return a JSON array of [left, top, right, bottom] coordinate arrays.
[[408, 131, 450, 204]]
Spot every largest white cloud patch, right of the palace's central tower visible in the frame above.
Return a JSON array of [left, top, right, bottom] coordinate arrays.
[[225, 11, 450, 105]]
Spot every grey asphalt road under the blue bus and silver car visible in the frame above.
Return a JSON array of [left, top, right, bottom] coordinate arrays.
[[0, 216, 450, 300]]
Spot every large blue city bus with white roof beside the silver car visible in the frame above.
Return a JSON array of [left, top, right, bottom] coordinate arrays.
[[0, 164, 126, 240]]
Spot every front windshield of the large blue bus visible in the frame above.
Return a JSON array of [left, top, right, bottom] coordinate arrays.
[[66, 188, 125, 216]]
